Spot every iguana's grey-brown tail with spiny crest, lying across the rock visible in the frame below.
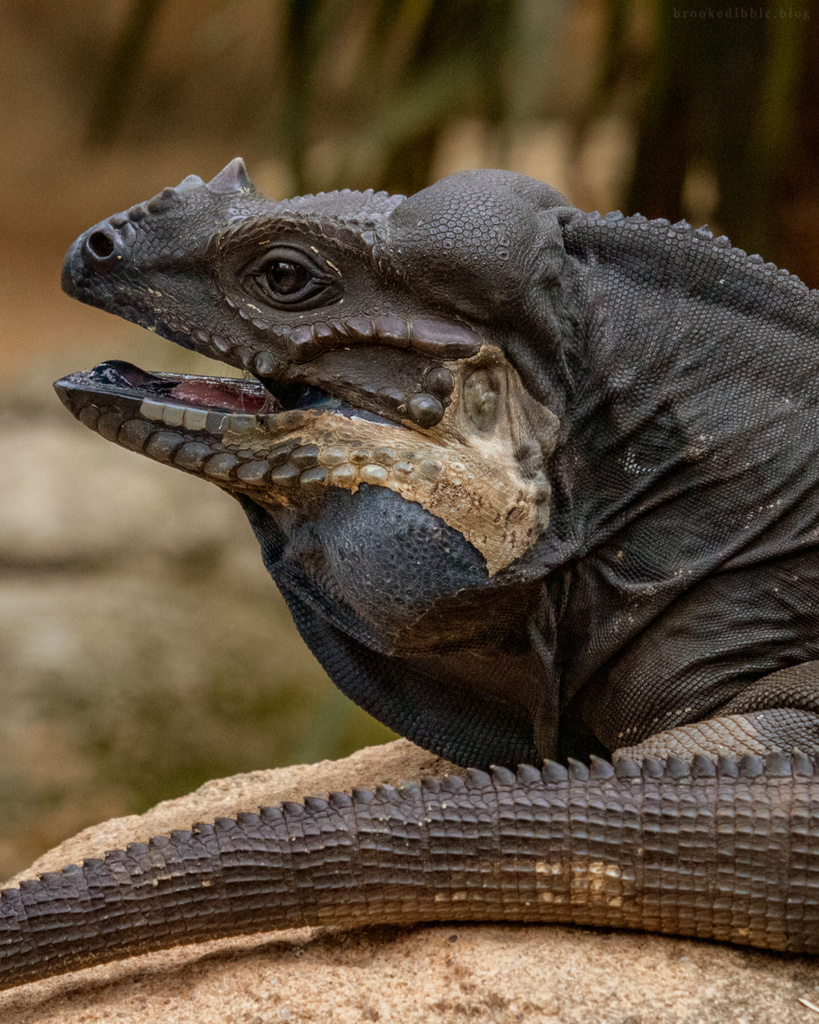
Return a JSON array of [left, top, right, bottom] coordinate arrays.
[[0, 755, 819, 987]]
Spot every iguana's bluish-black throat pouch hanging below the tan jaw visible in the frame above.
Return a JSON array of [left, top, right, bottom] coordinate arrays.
[[236, 419, 557, 763]]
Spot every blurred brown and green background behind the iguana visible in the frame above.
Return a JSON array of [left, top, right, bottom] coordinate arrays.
[[0, 0, 819, 878]]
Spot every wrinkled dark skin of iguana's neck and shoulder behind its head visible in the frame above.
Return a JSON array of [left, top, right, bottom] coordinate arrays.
[[532, 224, 819, 751]]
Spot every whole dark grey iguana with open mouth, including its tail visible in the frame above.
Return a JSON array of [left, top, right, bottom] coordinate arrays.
[[0, 161, 819, 985]]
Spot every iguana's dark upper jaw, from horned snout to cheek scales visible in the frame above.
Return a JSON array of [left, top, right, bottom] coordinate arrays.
[[62, 177, 485, 429]]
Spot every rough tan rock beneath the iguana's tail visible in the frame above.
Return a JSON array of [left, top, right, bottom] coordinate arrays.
[[0, 740, 819, 1024]]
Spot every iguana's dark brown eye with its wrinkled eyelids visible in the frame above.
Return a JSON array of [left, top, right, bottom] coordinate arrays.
[[246, 246, 341, 309]]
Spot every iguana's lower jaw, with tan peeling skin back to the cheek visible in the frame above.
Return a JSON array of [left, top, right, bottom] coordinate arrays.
[[54, 365, 548, 577]]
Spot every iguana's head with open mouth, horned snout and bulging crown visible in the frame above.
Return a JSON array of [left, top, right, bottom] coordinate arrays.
[[56, 160, 567, 655]]
